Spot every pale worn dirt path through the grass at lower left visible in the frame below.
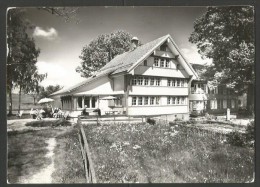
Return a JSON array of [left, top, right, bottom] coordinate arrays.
[[20, 138, 56, 184]]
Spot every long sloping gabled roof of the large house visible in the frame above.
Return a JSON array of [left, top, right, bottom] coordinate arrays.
[[51, 34, 197, 96]]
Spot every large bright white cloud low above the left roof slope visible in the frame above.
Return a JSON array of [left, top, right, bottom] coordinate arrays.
[[36, 61, 84, 87]]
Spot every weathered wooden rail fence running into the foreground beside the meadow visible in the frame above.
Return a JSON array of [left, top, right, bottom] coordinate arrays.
[[78, 121, 97, 183]]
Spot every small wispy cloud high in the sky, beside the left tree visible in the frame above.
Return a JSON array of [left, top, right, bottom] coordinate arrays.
[[33, 27, 58, 40]]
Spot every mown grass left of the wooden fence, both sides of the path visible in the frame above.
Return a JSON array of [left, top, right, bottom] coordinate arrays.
[[8, 120, 85, 184]]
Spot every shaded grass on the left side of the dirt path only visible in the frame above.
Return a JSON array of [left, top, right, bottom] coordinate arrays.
[[7, 129, 60, 183]]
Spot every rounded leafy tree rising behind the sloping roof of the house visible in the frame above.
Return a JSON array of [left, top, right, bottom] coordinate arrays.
[[76, 30, 132, 77]]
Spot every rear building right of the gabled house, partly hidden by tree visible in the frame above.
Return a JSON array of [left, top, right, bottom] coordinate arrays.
[[189, 64, 239, 114]]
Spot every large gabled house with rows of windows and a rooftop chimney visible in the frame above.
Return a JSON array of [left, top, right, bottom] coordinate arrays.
[[51, 35, 199, 119]]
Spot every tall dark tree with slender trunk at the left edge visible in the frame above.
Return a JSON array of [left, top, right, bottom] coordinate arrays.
[[7, 9, 46, 115]]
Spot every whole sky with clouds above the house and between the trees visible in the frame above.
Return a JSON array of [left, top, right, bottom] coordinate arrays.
[[19, 7, 210, 89]]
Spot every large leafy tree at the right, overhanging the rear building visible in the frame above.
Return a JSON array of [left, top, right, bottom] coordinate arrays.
[[189, 6, 255, 112]]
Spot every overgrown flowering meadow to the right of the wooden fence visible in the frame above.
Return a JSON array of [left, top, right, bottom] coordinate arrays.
[[84, 123, 254, 183]]
